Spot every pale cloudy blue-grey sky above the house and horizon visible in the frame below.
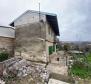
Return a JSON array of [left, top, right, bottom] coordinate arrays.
[[0, 0, 91, 41]]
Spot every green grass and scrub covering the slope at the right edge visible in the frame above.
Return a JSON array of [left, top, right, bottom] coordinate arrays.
[[70, 53, 91, 79]]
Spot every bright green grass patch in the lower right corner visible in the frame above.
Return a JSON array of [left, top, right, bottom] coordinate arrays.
[[71, 62, 91, 78]]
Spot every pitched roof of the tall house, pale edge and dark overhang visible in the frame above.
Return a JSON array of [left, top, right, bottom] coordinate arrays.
[[10, 10, 60, 36]]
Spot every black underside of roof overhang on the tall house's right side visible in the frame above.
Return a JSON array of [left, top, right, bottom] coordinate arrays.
[[46, 15, 60, 36]]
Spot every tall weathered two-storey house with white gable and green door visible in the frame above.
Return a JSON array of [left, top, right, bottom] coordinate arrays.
[[10, 10, 59, 62]]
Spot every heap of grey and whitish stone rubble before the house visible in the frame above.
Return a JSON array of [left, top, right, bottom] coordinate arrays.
[[3, 59, 49, 84]]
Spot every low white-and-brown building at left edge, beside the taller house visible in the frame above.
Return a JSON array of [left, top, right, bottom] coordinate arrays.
[[0, 26, 15, 56]]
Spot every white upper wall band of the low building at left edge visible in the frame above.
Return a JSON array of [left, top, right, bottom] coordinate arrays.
[[0, 27, 15, 38]]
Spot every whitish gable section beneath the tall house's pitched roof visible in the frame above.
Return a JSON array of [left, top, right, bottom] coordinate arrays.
[[14, 11, 46, 26]]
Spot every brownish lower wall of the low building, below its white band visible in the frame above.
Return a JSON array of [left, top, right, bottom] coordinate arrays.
[[0, 36, 14, 57]]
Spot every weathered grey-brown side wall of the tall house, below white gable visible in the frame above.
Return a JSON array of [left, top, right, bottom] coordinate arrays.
[[15, 22, 47, 62]]
